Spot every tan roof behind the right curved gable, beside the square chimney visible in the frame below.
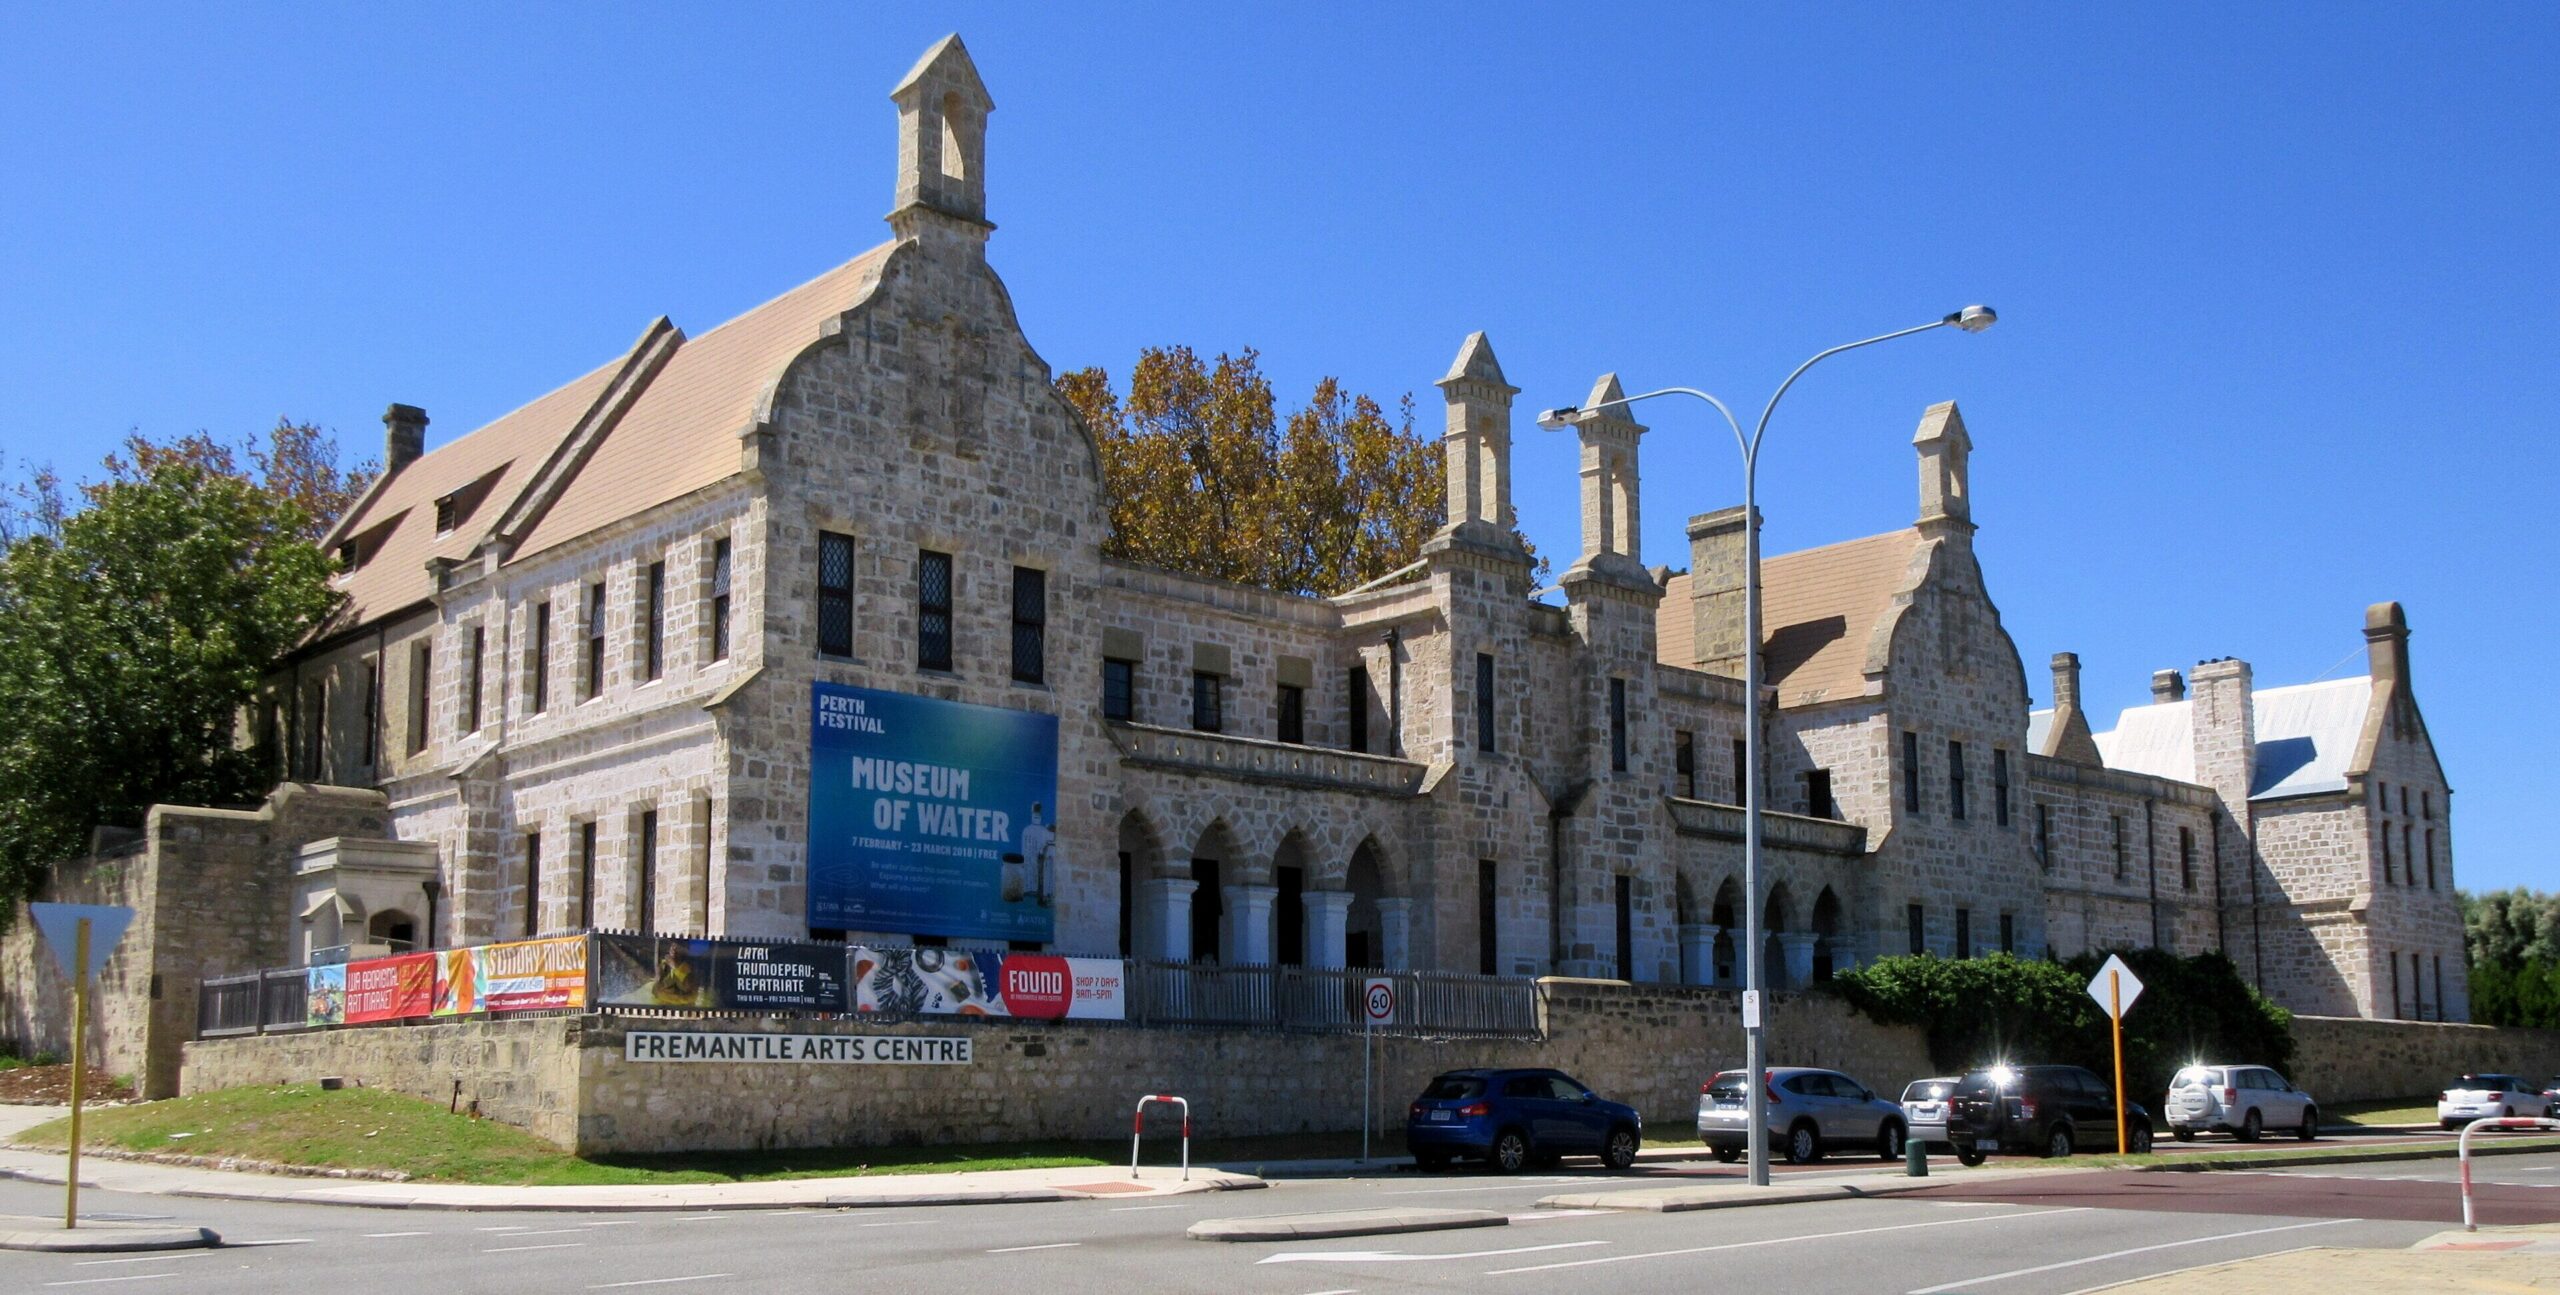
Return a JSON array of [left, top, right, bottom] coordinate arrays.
[[1654, 530, 1923, 706]]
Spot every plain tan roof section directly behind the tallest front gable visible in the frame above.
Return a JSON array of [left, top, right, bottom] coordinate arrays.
[[515, 243, 896, 555]]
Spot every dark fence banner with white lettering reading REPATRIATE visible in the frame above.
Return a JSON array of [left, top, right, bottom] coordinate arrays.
[[591, 934, 845, 1011]]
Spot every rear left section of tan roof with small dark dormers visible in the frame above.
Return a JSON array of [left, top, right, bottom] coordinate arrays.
[[312, 353, 627, 640]]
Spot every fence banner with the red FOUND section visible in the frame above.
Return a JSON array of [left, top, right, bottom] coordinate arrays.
[[852, 944, 1129, 1021]]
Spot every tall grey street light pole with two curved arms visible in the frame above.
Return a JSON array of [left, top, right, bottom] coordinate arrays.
[[1539, 305, 1999, 1188]]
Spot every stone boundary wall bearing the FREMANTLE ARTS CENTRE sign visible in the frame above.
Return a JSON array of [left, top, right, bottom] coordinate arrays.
[[187, 980, 1930, 1154]]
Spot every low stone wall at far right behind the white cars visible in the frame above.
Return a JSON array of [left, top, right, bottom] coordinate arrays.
[[2283, 1016, 2560, 1103]]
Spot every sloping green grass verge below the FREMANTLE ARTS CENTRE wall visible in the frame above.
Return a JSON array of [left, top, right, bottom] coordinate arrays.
[[18, 1085, 1398, 1185]]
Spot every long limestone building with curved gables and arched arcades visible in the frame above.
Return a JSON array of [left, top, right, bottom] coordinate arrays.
[[254, 38, 2463, 1019]]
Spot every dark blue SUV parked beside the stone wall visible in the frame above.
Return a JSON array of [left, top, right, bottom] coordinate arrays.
[[1405, 1070, 1644, 1175]]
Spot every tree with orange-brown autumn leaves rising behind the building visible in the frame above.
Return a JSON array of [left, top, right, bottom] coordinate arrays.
[[1057, 346, 1536, 594]]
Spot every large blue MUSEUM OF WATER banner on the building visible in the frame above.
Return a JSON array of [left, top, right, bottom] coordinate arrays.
[[809, 683, 1060, 944]]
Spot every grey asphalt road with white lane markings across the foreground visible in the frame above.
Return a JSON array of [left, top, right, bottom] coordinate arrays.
[[0, 1154, 2560, 1295]]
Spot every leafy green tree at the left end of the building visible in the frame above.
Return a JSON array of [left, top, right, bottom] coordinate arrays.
[[0, 422, 364, 896]]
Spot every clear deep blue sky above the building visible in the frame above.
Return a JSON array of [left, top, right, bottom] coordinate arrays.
[[0, 5, 2560, 888]]
